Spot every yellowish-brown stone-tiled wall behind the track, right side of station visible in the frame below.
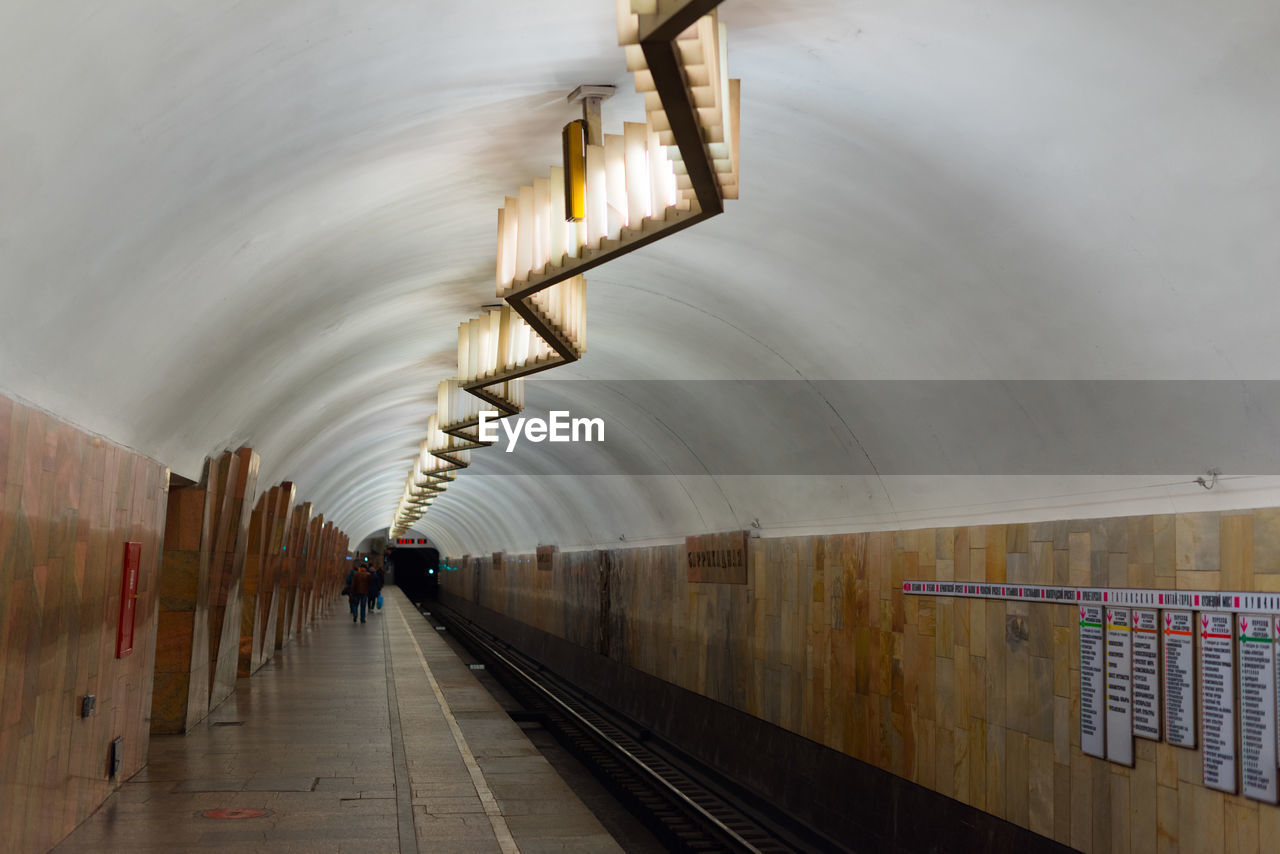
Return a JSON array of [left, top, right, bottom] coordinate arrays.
[[440, 508, 1280, 854]]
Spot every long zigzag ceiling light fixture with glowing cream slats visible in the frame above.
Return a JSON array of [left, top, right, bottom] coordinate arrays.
[[389, 0, 740, 536]]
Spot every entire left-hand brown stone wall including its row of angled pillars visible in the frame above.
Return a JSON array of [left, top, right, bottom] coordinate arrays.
[[0, 396, 348, 854]]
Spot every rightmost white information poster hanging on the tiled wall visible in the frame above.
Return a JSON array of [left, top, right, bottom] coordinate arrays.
[[1235, 613, 1276, 804]]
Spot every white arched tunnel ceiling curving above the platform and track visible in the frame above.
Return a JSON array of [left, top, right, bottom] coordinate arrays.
[[0, 0, 1280, 553]]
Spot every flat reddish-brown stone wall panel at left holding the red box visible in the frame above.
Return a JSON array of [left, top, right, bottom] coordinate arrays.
[[0, 396, 169, 853]]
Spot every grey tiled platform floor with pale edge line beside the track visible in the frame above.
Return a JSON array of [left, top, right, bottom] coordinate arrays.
[[54, 588, 621, 854]]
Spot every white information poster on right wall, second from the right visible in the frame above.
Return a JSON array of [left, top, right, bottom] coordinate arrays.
[[1199, 611, 1235, 794]]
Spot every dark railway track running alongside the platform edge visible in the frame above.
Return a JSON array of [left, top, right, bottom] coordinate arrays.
[[414, 602, 841, 854]]
